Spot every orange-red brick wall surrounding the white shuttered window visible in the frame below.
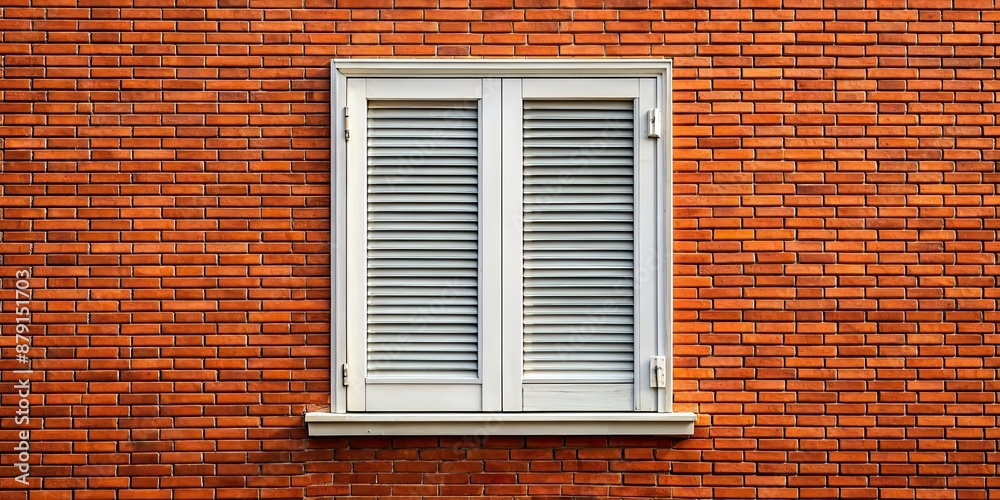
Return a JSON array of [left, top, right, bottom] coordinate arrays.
[[0, 0, 1000, 500]]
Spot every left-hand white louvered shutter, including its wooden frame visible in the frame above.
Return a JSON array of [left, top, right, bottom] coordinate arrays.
[[348, 80, 500, 411]]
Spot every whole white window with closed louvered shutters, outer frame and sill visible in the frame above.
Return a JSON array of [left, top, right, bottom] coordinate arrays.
[[307, 60, 693, 434]]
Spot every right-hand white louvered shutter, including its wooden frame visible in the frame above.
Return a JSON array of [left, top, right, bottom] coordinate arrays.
[[504, 80, 655, 411]]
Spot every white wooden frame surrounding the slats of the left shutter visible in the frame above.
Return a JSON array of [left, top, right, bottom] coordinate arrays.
[[346, 78, 502, 411]]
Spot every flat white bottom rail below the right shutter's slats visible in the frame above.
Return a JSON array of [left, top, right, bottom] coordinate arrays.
[[522, 383, 633, 411]]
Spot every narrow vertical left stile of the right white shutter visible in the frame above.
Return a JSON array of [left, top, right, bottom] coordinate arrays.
[[501, 78, 522, 411]]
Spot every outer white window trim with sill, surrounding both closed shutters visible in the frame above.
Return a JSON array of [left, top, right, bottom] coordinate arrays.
[[305, 59, 696, 436]]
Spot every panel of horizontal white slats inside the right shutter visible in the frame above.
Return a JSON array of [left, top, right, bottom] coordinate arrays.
[[522, 100, 635, 383]]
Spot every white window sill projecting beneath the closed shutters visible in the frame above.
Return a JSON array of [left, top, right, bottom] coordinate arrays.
[[305, 412, 696, 437]]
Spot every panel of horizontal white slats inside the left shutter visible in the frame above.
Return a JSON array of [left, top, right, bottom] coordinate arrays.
[[367, 101, 479, 380]]
